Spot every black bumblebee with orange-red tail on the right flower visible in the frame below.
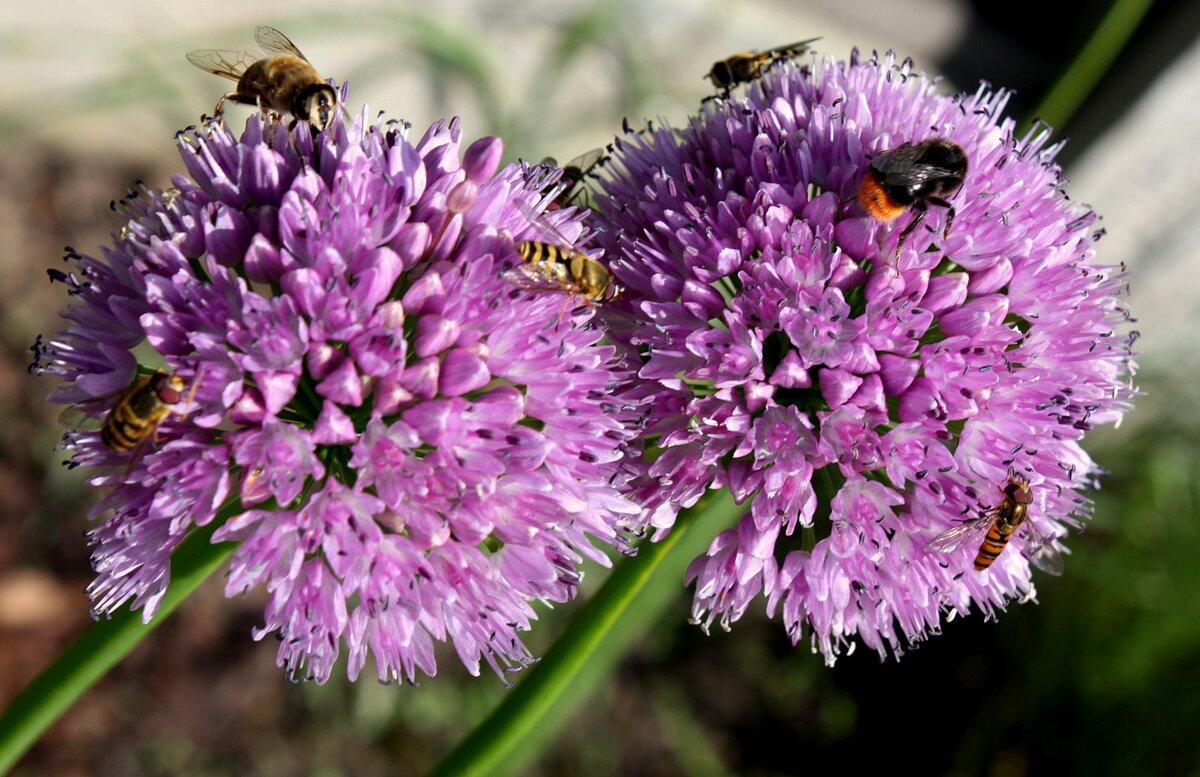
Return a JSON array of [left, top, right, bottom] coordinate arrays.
[[858, 138, 967, 246]]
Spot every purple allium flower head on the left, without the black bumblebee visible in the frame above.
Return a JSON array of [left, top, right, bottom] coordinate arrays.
[[36, 100, 641, 681]]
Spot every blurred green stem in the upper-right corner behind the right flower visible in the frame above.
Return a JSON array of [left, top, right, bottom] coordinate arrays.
[[1026, 0, 1153, 130]]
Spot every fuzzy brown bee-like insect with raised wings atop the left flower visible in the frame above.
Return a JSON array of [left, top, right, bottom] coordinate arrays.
[[187, 26, 337, 132]]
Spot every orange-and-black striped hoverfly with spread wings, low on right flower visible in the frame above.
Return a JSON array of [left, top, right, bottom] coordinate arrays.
[[925, 472, 1063, 576]]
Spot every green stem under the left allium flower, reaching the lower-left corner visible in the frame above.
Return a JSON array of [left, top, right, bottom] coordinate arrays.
[[0, 513, 241, 773]]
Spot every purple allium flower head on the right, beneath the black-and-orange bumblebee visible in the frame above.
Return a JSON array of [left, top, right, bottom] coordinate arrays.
[[600, 53, 1134, 662]]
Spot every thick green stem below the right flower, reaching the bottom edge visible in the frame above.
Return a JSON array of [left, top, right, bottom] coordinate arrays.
[[433, 492, 743, 777]]
